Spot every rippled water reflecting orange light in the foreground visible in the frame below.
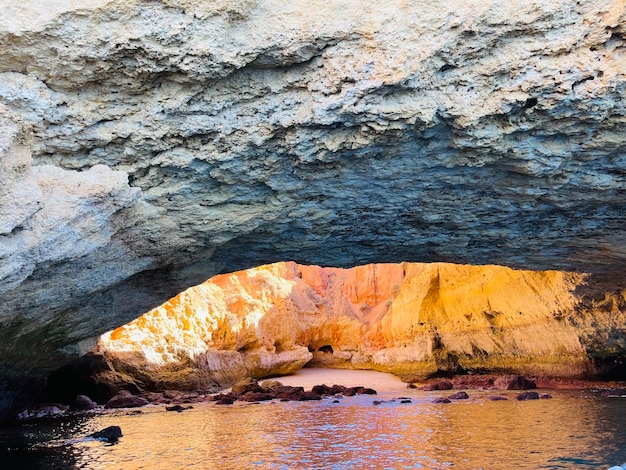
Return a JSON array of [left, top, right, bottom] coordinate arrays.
[[0, 390, 626, 469]]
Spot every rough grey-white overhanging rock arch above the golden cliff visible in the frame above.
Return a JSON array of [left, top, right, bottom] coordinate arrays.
[[0, 0, 626, 418]]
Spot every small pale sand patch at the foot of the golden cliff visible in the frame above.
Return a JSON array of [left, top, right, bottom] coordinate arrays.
[[271, 368, 407, 392]]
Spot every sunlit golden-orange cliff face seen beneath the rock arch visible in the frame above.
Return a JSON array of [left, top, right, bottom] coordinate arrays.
[[96, 262, 624, 388]]
